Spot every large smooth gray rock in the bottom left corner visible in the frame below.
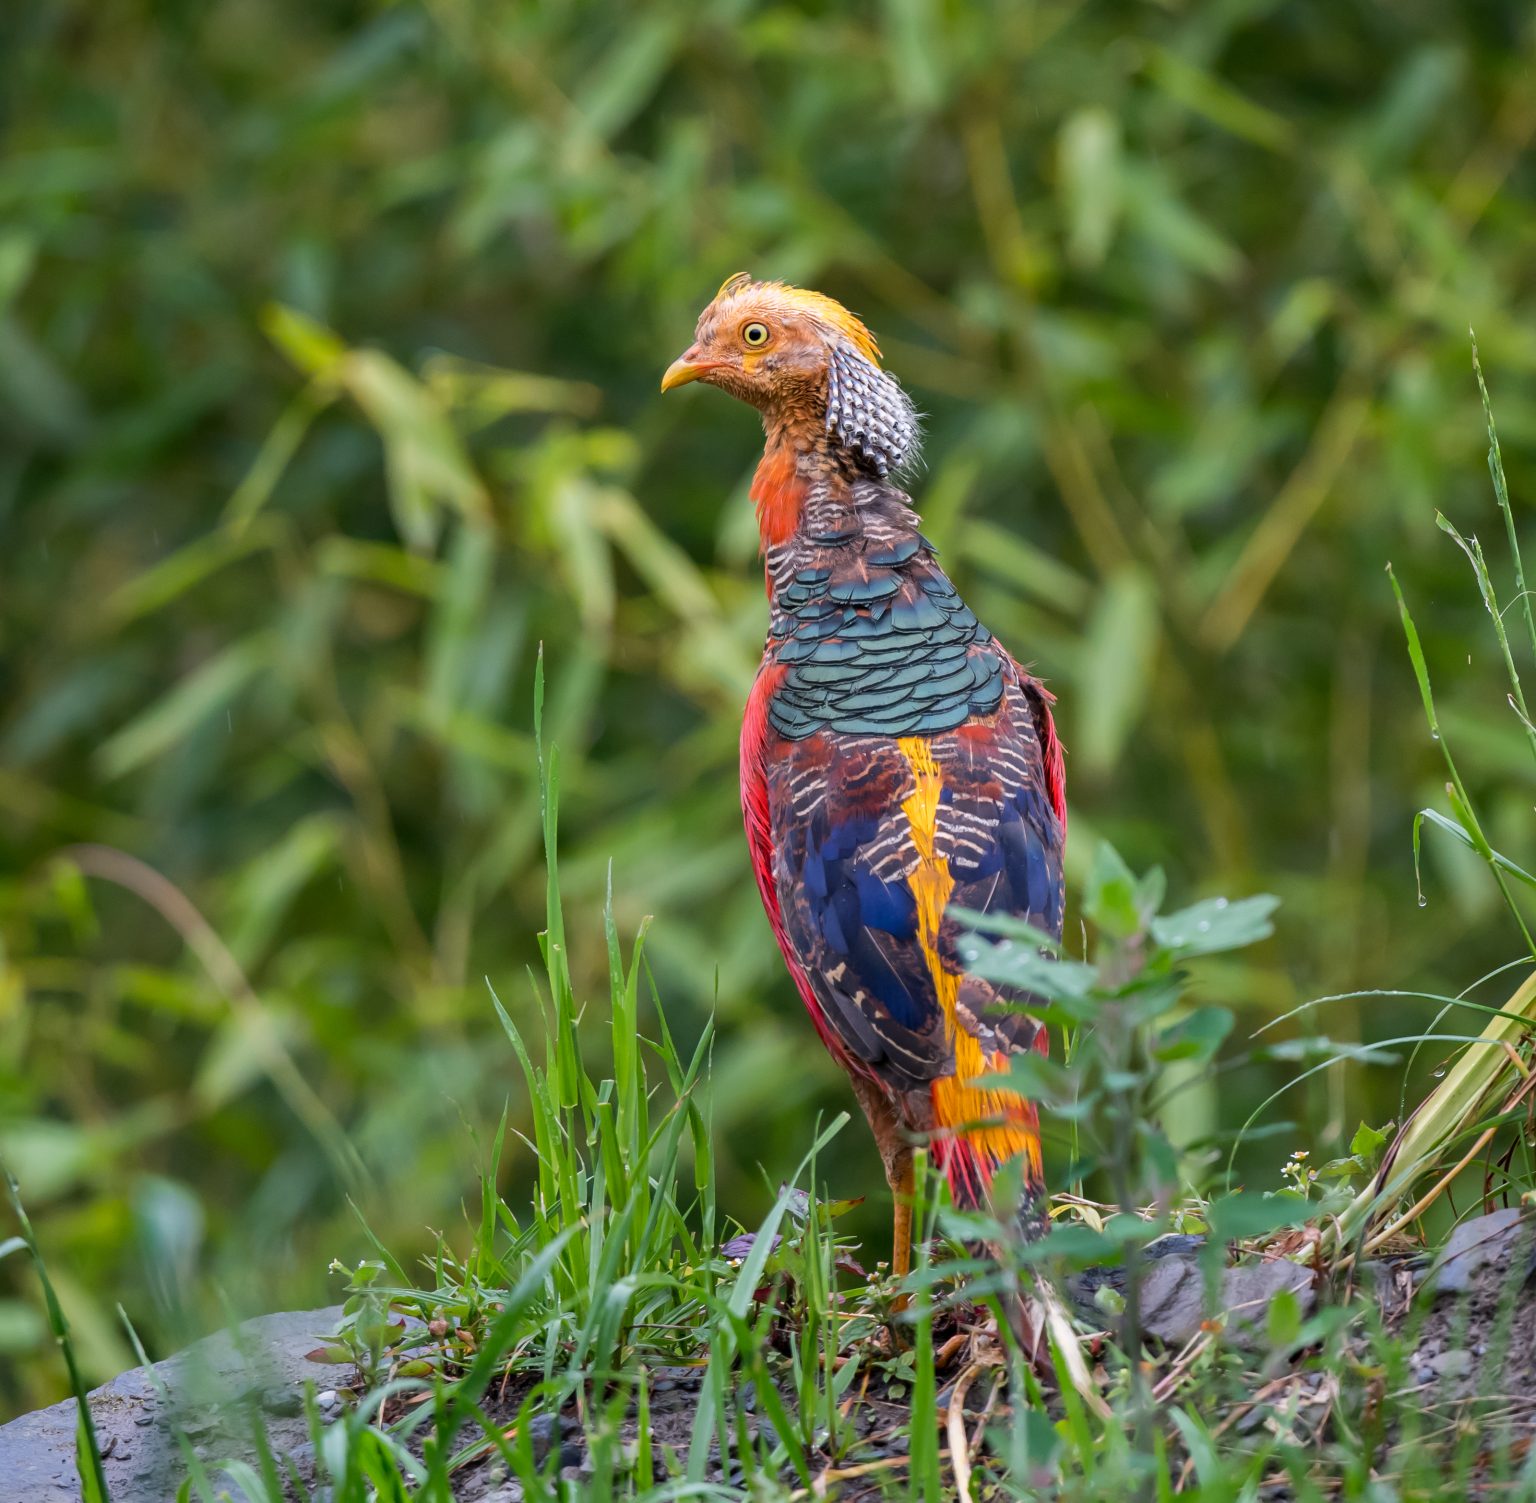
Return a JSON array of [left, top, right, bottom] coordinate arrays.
[[0, 1305, 341, 1503]]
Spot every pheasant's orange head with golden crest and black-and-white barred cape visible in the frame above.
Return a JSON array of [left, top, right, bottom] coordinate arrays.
[[662, 272, 919, 476]]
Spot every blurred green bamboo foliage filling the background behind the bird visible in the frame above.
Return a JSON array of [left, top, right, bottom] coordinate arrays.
[[0, 0, 1536, 1415]]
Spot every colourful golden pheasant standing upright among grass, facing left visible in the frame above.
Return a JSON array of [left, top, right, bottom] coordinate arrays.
[[662, 275, 1066, 1274]]
